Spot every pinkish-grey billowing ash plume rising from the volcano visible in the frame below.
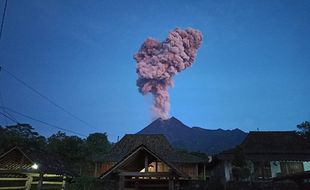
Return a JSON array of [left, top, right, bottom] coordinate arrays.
[[134, 28, 202, 119]]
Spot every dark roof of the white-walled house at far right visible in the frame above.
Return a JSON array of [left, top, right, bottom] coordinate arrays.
[[219, 131, 310, 160]]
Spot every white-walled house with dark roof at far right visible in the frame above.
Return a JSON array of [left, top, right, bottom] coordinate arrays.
[[213, 131, 310, 182]]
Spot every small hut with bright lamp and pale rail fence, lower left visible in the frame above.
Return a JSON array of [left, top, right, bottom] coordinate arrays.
[[0, 147, 69, 190]]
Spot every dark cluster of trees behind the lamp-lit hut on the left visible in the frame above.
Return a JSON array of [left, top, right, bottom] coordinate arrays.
[[0, 124, 111, 175]]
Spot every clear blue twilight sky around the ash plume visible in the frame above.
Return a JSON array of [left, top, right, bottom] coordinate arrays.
[[0, 0, 310, 142]]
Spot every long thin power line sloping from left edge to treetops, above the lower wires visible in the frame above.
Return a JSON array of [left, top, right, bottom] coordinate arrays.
[[0, 66, 99, 130]]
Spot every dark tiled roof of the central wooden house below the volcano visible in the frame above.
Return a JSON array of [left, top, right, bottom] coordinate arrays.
[[96, 134, 206, 163]]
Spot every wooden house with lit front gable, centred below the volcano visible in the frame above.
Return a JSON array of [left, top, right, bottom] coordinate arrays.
[[95, 134, 207, 190]]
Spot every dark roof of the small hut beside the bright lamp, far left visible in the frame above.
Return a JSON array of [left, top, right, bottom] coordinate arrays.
[[0, 146, 71, 174]]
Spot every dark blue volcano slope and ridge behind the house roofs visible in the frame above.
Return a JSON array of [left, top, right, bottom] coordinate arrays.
[[138, 117, 247, 154]]
